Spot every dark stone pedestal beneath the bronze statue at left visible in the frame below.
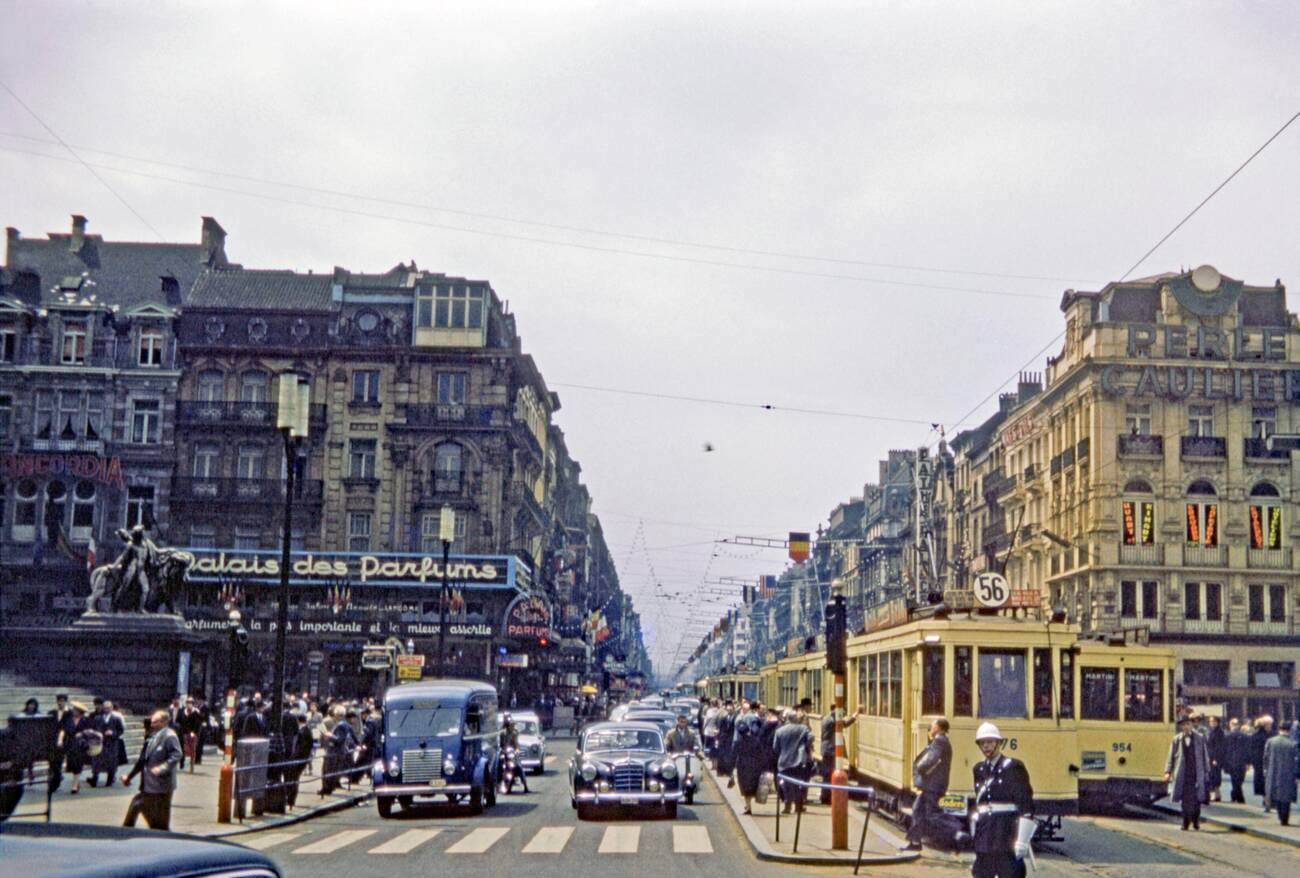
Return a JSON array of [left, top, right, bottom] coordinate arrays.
[[0, 613, 209, 713]]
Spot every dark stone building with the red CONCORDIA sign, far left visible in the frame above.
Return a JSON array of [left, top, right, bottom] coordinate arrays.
[[0, 216, 226, 620]]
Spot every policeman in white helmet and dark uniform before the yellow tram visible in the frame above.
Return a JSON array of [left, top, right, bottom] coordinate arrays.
[[971, 722, 1035, 878]]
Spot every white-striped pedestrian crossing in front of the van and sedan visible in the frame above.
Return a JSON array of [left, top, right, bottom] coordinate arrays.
[[239, 821, 714, 857]]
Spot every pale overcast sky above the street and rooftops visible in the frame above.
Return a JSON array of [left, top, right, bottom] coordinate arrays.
[[0, 0, 1300, 665]]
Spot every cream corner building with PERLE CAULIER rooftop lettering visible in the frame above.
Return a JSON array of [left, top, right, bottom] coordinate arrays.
[[984, 267, 1300, 718]]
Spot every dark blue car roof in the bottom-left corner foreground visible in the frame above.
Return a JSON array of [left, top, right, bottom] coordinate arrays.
[[0, 822, 280, 878]]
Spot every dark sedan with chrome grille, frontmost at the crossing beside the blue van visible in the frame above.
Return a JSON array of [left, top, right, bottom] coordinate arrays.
[[568, 721, 681, 819]]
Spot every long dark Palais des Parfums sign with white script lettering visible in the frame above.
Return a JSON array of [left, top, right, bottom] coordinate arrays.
[[185, 546, 532, 591]]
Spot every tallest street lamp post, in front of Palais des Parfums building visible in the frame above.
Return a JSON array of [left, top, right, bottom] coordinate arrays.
[[268, 372, 311, 810]]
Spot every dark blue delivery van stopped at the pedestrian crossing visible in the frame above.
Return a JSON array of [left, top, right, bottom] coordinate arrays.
[[372, 680, 501, 817]]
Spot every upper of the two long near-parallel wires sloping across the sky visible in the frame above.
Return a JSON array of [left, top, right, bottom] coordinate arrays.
[[0, 131, 1096, 284]]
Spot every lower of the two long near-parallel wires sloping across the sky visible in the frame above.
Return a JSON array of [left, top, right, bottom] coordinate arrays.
[[0, 147, 1050, 302]]
